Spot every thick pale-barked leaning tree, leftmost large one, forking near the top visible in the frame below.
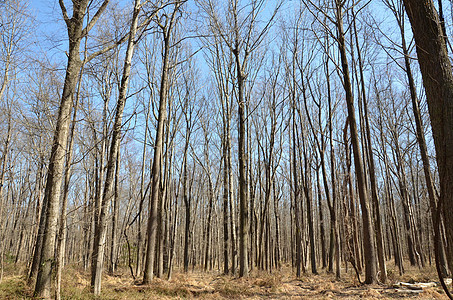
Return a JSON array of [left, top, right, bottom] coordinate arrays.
[[34, 0, 109, 299]]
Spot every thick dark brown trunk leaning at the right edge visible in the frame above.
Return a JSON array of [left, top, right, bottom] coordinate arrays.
[[404, 0, 453, 276]]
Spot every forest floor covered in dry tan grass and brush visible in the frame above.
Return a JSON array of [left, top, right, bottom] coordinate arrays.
[[0, 265, 447, 300]]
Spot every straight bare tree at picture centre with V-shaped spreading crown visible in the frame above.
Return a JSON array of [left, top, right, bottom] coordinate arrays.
[[203, 0, 281, 277]]
